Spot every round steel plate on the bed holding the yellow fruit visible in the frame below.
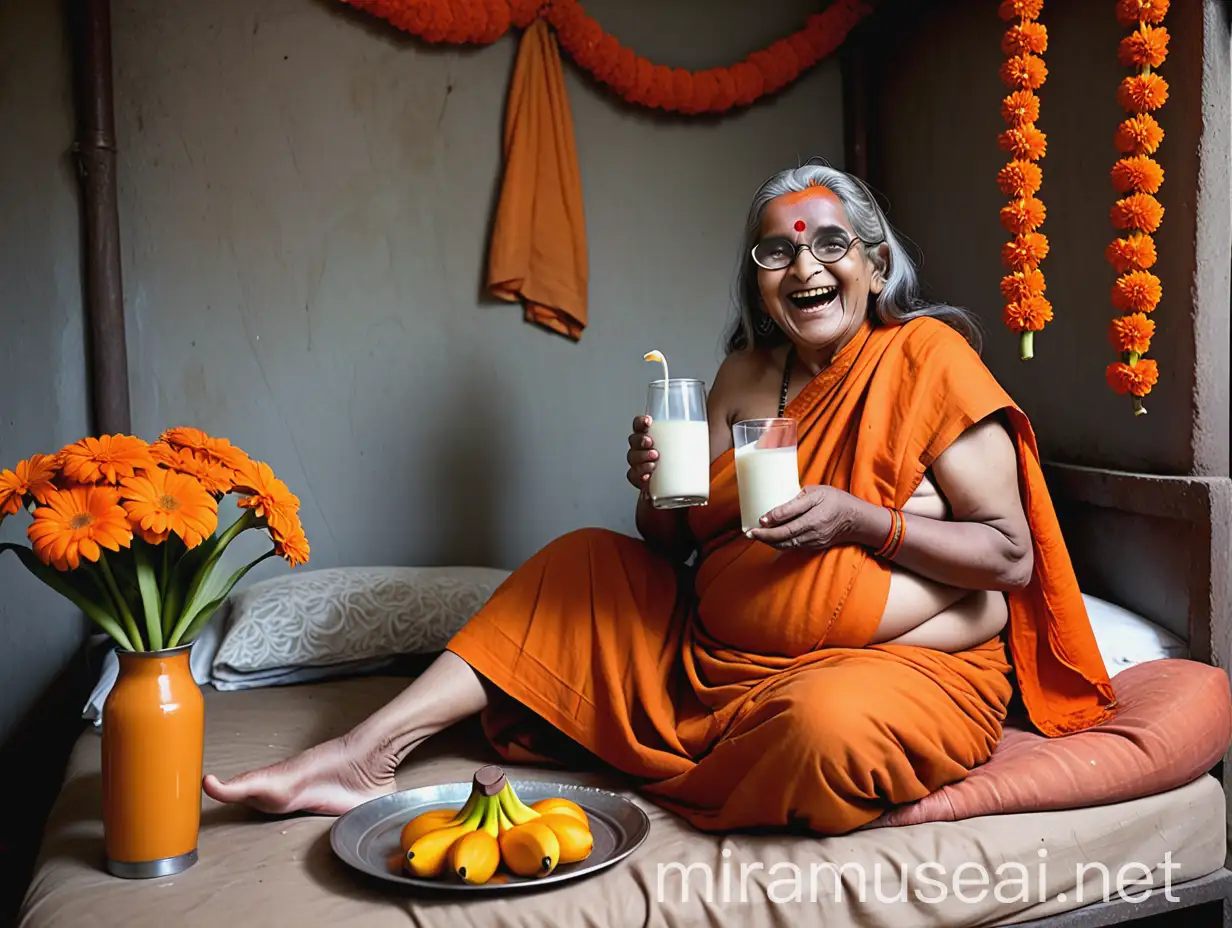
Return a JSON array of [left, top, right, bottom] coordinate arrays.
[[329, 780, 650, 892]]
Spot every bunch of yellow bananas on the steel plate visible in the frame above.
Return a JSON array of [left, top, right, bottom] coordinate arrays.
[[402, 765, 594, 885]]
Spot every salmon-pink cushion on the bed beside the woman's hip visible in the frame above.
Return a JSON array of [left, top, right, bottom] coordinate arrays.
[[866, 659, 1232, 828]]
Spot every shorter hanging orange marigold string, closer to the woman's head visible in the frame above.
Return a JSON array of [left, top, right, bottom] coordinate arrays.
[[997, 0, 1052, 361]]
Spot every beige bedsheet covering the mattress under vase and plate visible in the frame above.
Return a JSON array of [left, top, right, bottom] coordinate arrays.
[[18, 678, 1225, 928]]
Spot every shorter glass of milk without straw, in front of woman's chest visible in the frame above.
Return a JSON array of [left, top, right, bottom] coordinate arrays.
[[732, 419, 800, 531]]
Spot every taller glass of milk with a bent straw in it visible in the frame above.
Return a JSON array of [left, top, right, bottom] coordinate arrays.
[[646, 377, 710, 509]]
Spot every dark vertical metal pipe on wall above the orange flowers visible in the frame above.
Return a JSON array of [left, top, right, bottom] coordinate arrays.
[[74, 0, 132, 434]]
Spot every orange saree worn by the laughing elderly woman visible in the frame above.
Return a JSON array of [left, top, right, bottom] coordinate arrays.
[[450, 319, 1115, 834]]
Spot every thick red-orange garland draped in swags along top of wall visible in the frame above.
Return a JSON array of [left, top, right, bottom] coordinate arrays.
[[342, 0, 872, 113]]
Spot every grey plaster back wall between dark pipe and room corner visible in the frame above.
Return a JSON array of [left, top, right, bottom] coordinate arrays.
[[115, 0, 843, 577]]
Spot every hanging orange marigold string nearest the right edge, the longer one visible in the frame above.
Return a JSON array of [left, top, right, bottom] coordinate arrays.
[[1104, 0, 1169, 415]]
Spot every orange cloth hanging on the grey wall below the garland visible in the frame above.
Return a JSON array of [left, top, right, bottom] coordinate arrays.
[[488, 18, 589, 340]]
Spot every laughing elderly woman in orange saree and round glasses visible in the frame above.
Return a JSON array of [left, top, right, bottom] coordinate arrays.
[[205, 165, 1114, 834]]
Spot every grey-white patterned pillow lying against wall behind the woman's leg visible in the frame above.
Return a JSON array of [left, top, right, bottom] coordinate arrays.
[[213, 567, 509, 689]]
